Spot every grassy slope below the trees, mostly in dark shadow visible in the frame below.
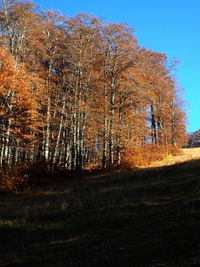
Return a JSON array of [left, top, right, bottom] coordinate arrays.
[[0, 149, 200, 267]]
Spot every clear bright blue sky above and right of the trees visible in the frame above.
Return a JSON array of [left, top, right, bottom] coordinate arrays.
[[33, 0, 200, 131]]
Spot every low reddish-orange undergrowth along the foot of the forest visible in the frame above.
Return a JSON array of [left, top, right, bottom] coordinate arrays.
[[0, 144, 181, 192]]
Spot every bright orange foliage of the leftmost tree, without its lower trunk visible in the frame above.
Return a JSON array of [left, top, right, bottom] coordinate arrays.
[[0, 49, 37, 140]]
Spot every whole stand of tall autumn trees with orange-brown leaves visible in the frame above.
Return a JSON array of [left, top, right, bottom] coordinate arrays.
[[0, 0, 187, 191]]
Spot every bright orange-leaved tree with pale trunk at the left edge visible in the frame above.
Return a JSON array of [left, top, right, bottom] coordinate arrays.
[[0, 49, 37, 170]]
